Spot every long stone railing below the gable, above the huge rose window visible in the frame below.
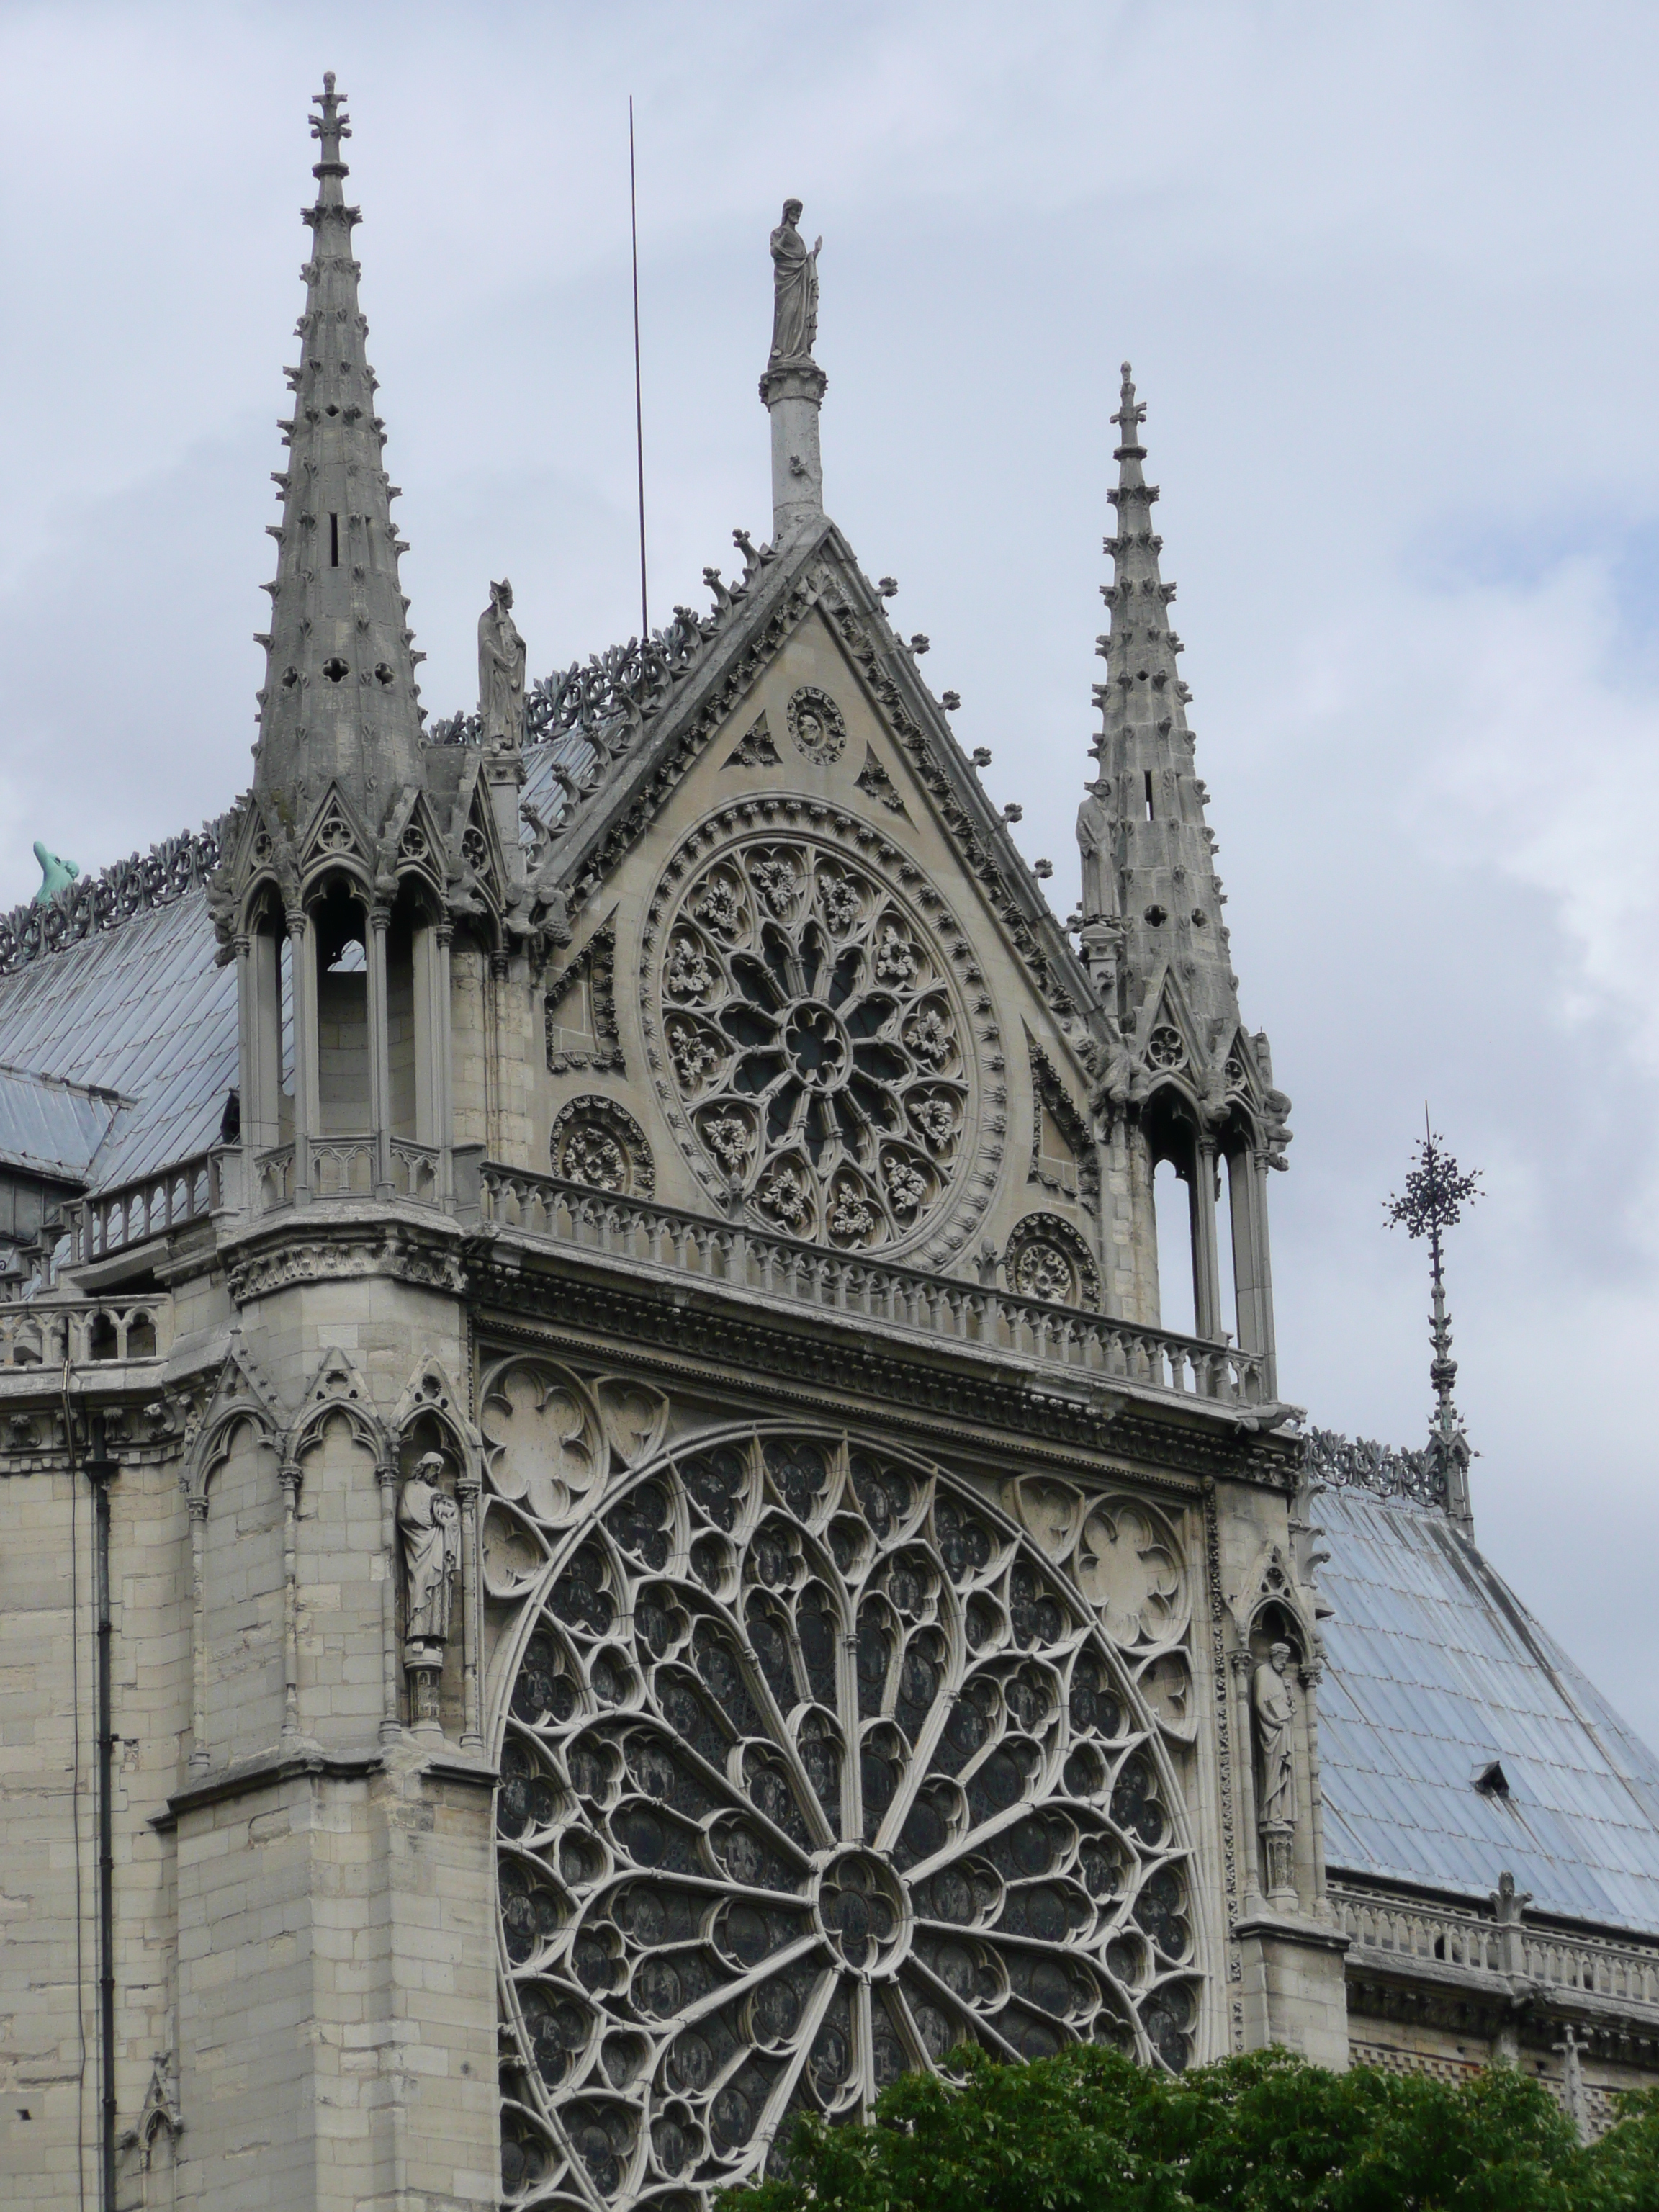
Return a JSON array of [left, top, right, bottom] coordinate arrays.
[[478, 1161, 1267, 1407]]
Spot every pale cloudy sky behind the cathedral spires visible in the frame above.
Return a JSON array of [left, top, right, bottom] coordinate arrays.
[[0, 0, 1659, 1741]]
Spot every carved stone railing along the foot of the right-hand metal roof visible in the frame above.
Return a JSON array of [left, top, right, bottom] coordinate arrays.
[[1329, 1882, 1659, 2006]]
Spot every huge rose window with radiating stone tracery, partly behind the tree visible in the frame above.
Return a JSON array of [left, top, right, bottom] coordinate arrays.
[[495, 1436, 1201, 2206]]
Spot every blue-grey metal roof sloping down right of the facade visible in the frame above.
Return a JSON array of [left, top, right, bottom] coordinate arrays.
[[1316, 1488, 1659, 1933]]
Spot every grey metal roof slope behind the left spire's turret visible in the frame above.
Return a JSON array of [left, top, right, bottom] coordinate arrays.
[[0, 889, 237, 1190]]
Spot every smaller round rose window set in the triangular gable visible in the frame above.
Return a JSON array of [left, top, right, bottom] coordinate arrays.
[[659, 838, 971, 1250]]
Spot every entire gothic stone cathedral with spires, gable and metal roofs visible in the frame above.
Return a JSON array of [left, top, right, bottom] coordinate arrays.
[[0, 80, 1659, 2212]]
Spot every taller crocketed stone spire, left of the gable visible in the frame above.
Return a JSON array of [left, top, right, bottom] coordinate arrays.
[[254, 71, 423, 830]]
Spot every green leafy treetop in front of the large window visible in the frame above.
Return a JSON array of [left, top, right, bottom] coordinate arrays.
[[721, 2044, 1659, 2212]]
